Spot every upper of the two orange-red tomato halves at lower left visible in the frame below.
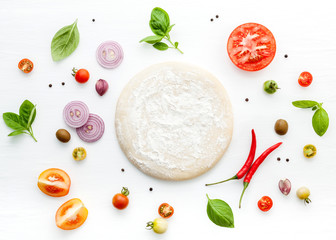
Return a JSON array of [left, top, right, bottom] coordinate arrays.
[[37, 168, 71, 197]]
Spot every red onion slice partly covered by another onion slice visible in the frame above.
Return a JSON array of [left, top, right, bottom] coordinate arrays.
[[76, 113, 105, 142]]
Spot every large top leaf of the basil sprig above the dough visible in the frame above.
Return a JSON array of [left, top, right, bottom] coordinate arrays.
[[149, 7, 170, 36]]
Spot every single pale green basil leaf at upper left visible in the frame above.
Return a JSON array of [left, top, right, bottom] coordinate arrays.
[[51, 19, 79, 61]]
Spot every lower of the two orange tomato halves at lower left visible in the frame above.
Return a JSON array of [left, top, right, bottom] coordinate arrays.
[[55, 198, 88, 230]]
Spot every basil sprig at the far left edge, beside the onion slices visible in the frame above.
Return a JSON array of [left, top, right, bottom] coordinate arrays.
[[2, 100, 37, 142]]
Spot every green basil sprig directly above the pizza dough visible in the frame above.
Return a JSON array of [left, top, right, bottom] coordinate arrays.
[[140, 7, 183, 54]]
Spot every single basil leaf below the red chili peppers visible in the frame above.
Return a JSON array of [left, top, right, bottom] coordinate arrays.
[[207, 195, 234, 228]]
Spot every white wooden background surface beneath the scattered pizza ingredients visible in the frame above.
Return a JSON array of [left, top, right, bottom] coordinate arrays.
[[0, 0, 336, 240]]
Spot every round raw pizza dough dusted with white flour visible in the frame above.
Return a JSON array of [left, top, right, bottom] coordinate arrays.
[[115, 62, 233, 180]]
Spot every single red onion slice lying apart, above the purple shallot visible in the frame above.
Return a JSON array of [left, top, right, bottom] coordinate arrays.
[[96, 41, 124, 68]]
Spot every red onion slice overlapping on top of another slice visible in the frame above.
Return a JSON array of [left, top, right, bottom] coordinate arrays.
[[63, 101, 89, 128]]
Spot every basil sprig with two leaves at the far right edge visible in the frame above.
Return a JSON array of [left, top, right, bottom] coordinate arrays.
[[292, 100, 329, 137]]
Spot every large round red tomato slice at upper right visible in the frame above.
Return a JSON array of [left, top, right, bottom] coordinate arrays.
[[227, 23, 276, 71]]
